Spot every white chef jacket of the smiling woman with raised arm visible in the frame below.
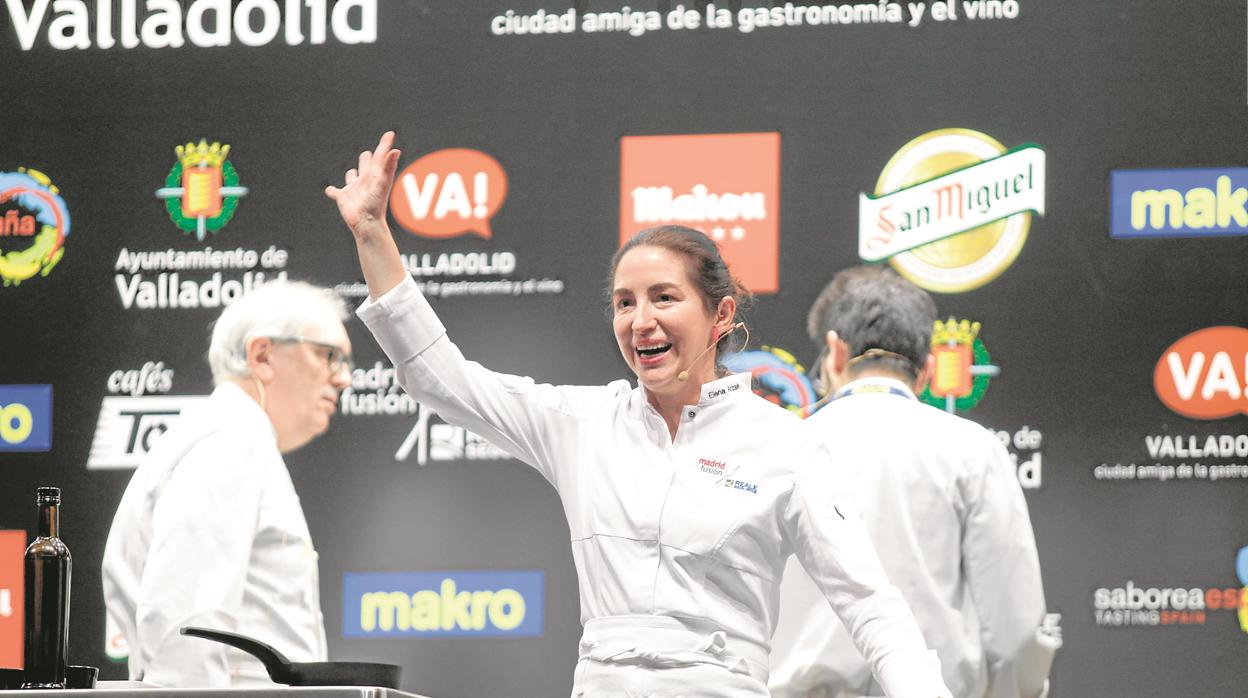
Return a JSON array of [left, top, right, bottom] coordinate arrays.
[[357, 278, 947, 698]]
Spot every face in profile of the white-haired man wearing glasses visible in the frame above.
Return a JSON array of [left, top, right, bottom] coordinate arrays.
[[261, 322, 351, 453]]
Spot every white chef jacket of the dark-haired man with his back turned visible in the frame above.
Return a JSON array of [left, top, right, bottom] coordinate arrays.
[[771, 377, 1060, 698]]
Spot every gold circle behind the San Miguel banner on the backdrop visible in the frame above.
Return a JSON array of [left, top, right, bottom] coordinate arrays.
[[875, 129, 1031, 293]]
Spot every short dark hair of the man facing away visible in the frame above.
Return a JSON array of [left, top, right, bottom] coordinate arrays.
[[806, 265, 936, 380]]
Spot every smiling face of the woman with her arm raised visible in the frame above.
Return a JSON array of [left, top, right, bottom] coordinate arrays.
[[612, 245, 735, 406]]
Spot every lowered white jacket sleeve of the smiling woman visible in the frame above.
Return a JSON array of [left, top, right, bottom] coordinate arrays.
[[785, 446, 952, 698]]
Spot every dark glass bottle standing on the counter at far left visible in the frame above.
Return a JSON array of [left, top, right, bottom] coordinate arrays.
[[22, 487, 71, 688]]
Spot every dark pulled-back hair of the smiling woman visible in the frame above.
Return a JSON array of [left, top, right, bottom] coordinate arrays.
[[607, 225, 754, 356]]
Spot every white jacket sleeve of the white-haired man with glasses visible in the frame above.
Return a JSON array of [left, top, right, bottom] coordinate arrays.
[[131, 432, 265, 688]]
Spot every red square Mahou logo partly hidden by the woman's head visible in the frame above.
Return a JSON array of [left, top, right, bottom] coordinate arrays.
[[620, 132, 780, 293]]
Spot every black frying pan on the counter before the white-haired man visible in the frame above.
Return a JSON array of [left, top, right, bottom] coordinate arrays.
[[181, 626, 403, 689]]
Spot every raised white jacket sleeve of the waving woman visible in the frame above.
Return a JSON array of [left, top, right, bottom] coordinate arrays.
[[356, 277, 609, 484]]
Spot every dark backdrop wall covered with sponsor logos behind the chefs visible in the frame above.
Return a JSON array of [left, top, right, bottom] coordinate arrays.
[[0, 0, 1248, 698]]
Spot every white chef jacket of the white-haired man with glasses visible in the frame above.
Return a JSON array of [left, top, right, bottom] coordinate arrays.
[[104, 383, 326, 687]]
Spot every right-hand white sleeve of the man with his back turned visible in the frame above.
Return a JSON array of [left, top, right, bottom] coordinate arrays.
[[960, 438, 1060, 698]]
